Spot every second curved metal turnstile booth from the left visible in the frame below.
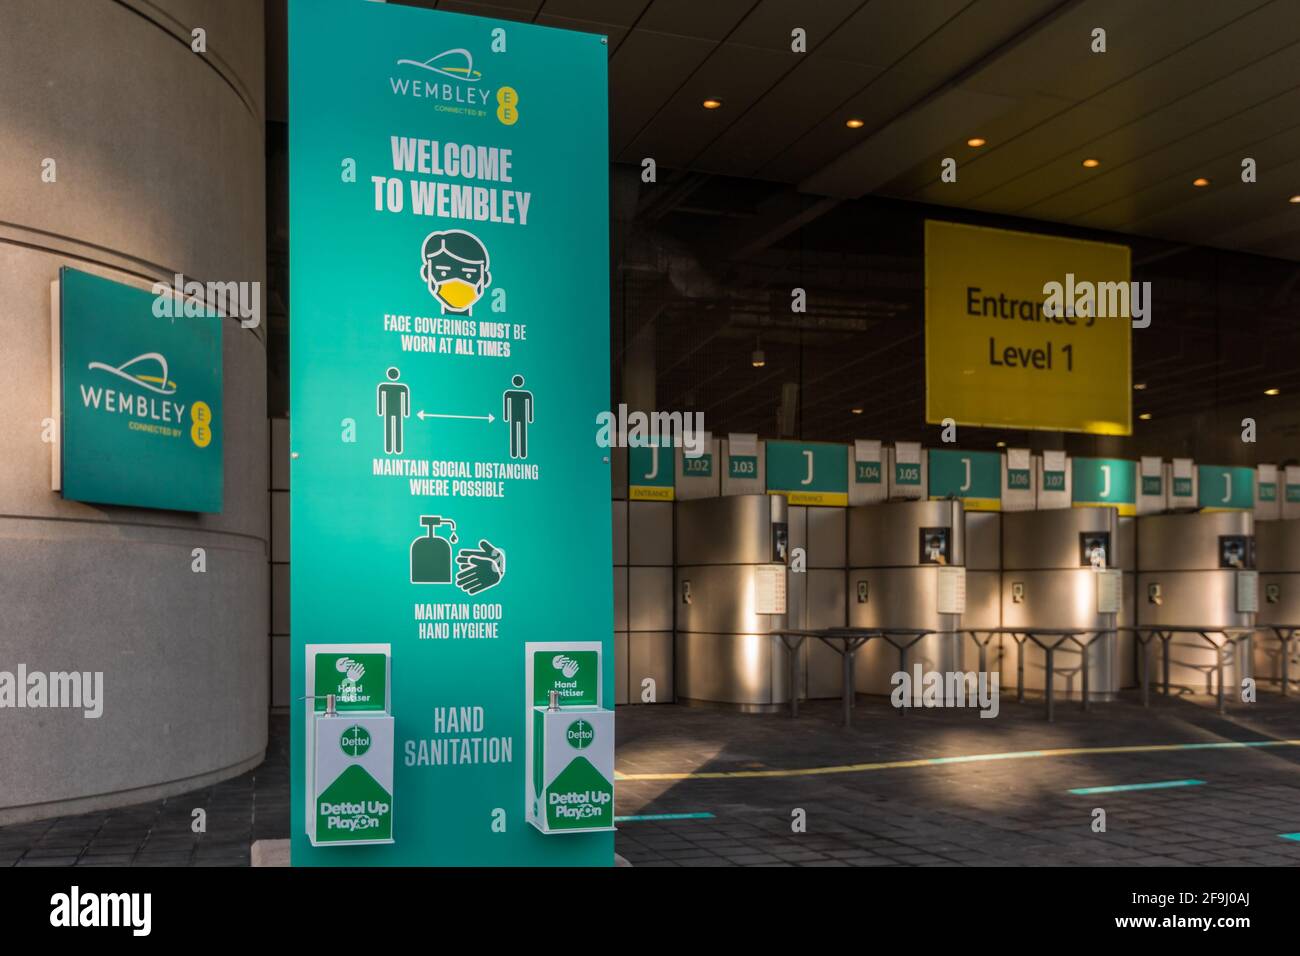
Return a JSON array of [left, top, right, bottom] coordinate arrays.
[[848, 501, 966, 695]]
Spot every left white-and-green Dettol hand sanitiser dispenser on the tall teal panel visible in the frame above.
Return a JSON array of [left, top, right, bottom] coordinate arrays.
[[306, 644, 394, 847]]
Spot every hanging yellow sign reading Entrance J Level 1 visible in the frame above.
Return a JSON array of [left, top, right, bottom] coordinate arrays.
[[926, 220, 1128, 434]]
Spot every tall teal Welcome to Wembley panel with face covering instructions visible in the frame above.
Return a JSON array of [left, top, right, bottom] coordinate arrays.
[[289, 0, 608, 866]]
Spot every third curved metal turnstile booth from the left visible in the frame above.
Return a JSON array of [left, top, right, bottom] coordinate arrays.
[[1002, 507, 1132, 700]]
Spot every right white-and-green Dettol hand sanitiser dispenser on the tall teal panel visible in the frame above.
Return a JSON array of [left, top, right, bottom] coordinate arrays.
[[525, 641, 614, 834]]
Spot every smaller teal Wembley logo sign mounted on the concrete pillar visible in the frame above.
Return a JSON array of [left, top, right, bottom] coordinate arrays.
[[57, 268, 224, 512]]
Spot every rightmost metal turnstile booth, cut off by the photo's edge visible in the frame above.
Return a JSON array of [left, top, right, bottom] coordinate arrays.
[[1255, 518, 1300, 684]]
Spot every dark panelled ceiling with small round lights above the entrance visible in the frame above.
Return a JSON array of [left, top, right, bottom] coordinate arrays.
[[411, 0, 1300, 260]]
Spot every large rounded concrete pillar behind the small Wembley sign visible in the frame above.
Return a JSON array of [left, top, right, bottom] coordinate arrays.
[[0, 0, 269, 825]]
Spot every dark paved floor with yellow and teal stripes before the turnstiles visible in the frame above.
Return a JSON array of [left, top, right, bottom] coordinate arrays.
[[0, 695, 1300, 866]]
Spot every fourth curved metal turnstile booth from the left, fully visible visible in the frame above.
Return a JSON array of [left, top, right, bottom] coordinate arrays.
[[1136, 511, 1258, 693]]
